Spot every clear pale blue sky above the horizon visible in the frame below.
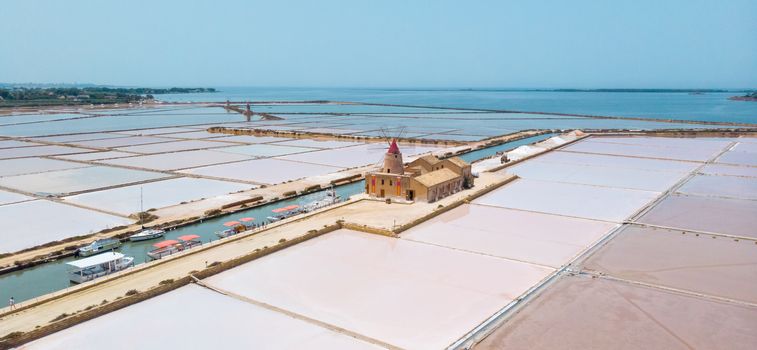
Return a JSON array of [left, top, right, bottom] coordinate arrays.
[[0, 0, 757, 88]]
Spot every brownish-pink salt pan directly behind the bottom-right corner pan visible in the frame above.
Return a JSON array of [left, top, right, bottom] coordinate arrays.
[[584, 225, 757, 303]]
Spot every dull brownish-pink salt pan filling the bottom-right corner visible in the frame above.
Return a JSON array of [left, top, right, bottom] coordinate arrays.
[[475, 277, 757, 350]]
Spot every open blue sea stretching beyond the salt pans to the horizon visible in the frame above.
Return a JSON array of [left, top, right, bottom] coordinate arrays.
[[156, 87, 757, 124]]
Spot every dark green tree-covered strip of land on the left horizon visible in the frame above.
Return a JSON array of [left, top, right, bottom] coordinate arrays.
[[0, 86, 216, 108]]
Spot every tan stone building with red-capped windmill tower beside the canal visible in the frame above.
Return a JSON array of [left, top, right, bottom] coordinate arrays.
[[365, 140, 473, 202]]
